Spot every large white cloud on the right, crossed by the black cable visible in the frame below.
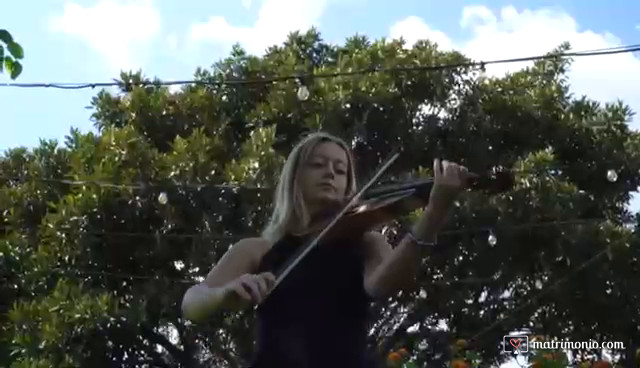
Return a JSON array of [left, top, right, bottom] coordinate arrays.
[[390, 6, 640, 129]]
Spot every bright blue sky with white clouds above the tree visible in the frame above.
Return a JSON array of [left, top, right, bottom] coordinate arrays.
[[0, 0, 640, 364]]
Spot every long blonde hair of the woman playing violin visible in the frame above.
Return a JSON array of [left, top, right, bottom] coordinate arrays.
[[262, 132, 356, 242]]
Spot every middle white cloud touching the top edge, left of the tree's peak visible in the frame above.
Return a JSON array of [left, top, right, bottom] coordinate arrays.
[[190, 0, 328, 55]]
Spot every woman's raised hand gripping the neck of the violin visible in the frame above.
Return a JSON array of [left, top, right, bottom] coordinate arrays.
[[429, 159, 471, 210]]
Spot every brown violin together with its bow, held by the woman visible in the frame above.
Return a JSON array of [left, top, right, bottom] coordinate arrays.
[[260, 153, 515, 302]]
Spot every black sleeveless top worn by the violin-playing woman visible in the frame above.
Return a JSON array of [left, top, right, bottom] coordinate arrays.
[[251, 235, 377, 368]]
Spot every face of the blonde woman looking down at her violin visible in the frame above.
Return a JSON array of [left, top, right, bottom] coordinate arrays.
[[298, 142, 349, 212]]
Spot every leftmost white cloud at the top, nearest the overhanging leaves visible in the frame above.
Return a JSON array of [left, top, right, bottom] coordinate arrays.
[[49, 0, 161, 72]]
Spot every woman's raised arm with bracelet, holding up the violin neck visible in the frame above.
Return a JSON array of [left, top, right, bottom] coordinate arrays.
[[364, 160, 468, 298]]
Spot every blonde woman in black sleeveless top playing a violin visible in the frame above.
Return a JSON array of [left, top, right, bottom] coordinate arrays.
[[182, 133, 468, 368]]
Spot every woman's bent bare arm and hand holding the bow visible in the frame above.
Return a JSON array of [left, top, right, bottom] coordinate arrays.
[[182, 238, 275, 322]]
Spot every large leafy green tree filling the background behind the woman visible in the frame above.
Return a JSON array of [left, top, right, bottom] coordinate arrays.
[[0, 30, 640, 367]]
